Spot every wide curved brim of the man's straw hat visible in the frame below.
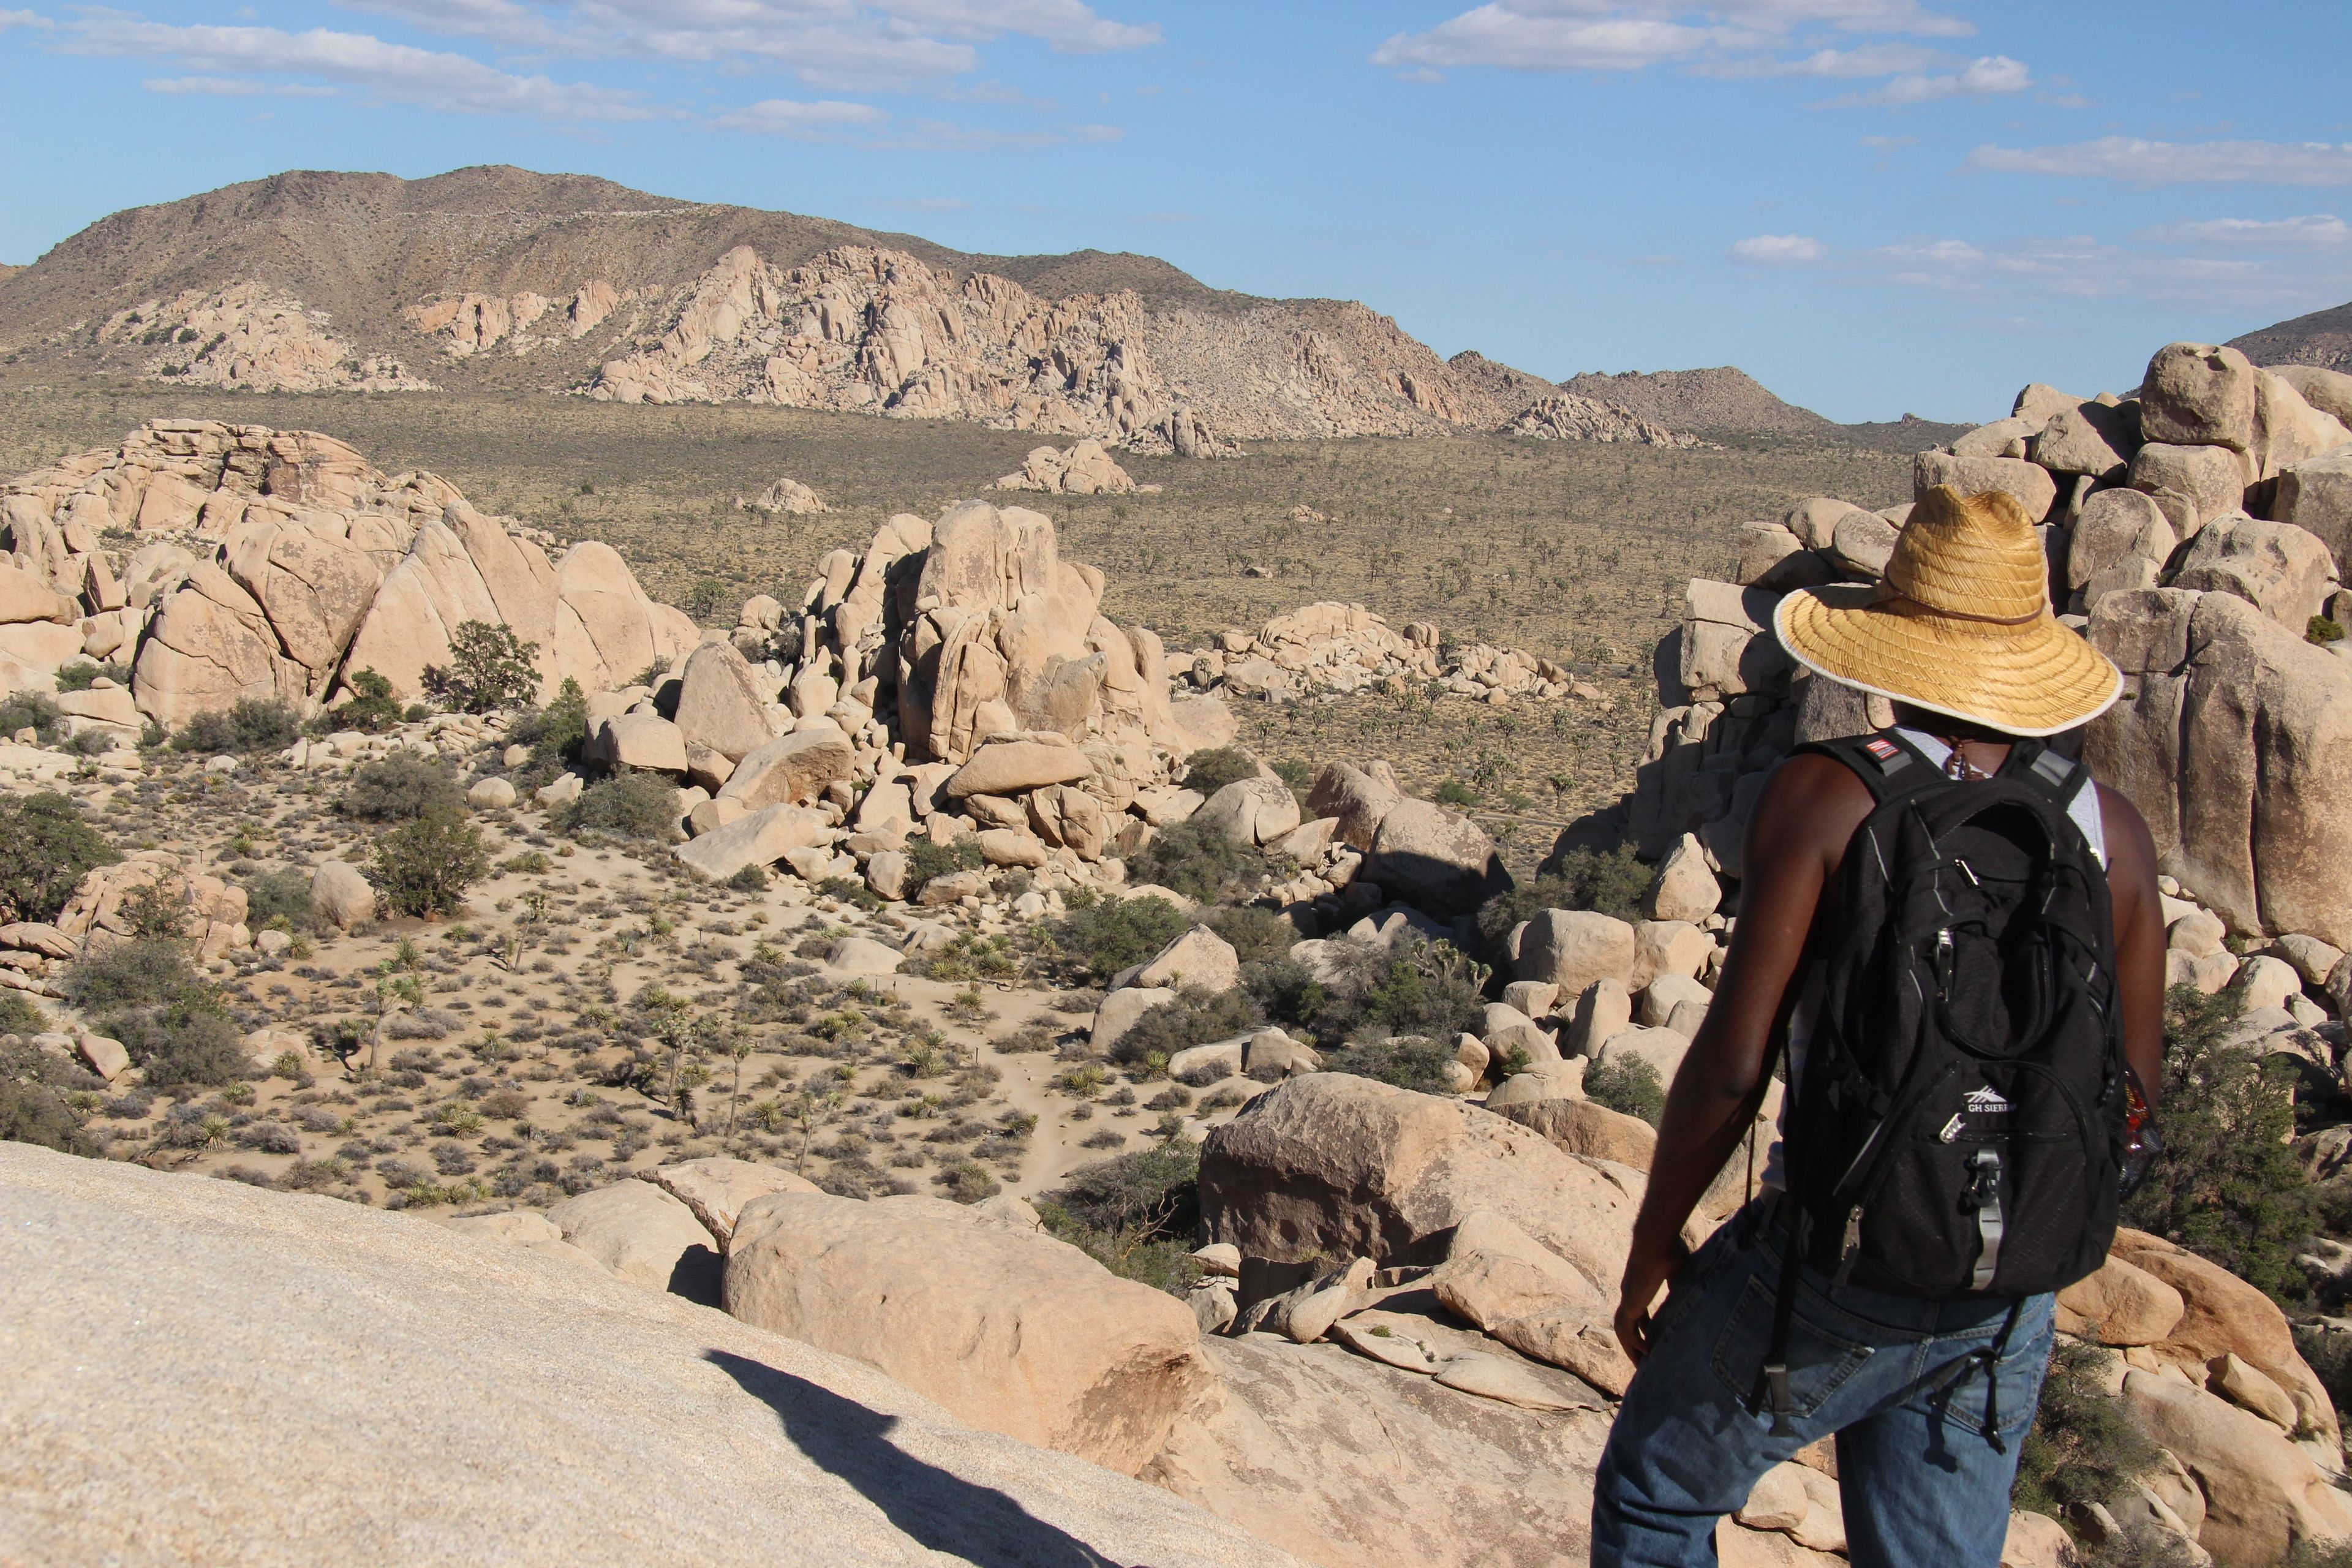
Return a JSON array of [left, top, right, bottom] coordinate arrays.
[[1773, 583, 2124, 736]]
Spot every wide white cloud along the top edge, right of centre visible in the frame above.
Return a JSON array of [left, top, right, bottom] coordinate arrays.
[[1371, 0, 1973, 78]]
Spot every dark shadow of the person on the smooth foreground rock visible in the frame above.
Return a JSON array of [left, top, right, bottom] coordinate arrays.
[[703, 1349, 1120, 1568]]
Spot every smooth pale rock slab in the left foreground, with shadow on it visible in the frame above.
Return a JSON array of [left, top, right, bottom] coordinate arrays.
[[0, 1142, 1296, 1568]]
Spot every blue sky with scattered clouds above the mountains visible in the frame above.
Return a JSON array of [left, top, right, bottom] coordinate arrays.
[[0, 0, 2352, 418]]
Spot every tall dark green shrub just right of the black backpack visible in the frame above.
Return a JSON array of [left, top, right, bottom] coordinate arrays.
[[2124, 985, 2312, 1302]]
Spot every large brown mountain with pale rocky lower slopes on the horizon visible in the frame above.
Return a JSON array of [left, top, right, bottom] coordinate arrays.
[[0, 167, 1580, 451]]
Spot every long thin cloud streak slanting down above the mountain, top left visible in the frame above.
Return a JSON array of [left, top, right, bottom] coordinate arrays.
[[59, 17, 663, 120]]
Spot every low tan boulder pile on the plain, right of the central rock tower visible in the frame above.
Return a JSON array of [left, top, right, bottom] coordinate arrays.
[[1188, 600, 1599, 705]]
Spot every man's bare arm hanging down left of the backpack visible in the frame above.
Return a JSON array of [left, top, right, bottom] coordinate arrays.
[[1616, 757, 1870, 1361]]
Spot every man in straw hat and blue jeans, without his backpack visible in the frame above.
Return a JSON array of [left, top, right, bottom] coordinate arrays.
[[1593, 486, 2164, 1568]]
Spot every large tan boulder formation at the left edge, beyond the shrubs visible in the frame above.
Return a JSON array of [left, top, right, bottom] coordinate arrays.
[[0, 418, 694, 726]]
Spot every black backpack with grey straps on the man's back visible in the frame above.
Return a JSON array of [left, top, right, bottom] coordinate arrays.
[[1755, 731, 2131, 1446]]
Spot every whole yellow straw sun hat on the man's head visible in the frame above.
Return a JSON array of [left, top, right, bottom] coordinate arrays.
[[1773, 484, 2124, 736]]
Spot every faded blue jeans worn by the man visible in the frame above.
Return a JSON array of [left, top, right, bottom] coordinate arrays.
[[1593, 1197, 2053, 1568]]
